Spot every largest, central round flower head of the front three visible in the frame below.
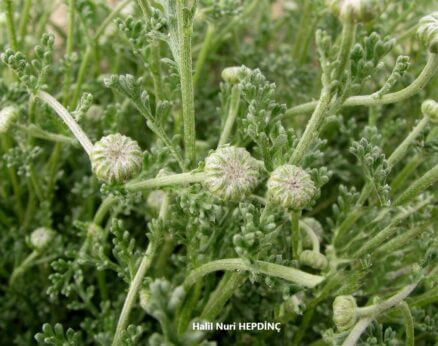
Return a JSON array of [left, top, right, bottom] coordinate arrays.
[[204, 146, 261, 201]]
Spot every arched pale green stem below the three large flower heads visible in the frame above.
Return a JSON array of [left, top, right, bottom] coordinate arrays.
[[184, 258, 324, 287]]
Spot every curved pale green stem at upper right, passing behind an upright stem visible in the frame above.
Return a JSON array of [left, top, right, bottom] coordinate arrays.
[[285, 53, 438, 116]]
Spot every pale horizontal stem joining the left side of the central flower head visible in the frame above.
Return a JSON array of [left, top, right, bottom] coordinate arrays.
[[125, 173, 205, 192]]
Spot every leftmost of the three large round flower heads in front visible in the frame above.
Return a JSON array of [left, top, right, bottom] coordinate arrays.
[[90, 133, 143, 183]]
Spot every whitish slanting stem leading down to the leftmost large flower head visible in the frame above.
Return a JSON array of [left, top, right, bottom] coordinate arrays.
[[36, 90, 93, 155]]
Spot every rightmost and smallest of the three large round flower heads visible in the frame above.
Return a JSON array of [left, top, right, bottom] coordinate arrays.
[[267, 165, 316, 210]]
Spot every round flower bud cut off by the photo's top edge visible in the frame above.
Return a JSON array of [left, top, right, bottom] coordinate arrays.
[[327, 0, 382, 23]]
